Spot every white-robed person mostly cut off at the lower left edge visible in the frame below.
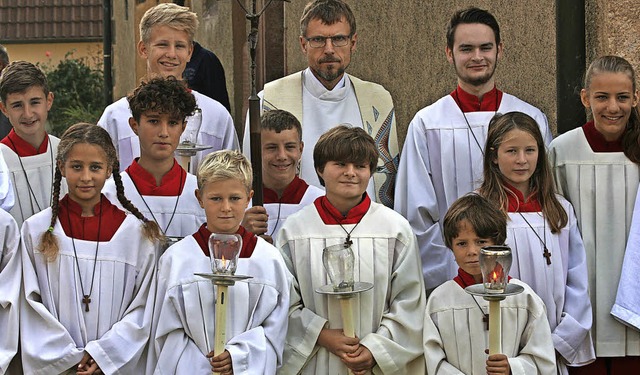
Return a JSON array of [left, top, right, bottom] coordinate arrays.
[[0, 208, 22, 374]]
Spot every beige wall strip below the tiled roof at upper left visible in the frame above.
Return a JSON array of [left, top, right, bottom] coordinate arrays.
[[4, 42, 102, 71]]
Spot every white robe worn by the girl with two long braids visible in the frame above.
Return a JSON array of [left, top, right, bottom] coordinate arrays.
[[20, 208, 158, 375]]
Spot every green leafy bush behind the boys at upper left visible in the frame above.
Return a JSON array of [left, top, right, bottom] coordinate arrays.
[[40, 52, 104, 137]]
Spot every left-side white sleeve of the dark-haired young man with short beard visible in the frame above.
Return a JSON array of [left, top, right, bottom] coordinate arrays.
[[394, 116, 455, 292]]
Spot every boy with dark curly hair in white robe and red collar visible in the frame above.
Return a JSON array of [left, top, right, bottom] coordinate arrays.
[[103, 77, 205, 247]]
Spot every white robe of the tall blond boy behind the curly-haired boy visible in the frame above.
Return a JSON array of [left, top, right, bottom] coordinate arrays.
[[98, 90, 239, 174]]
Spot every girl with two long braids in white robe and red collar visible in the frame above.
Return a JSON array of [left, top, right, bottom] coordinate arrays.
[[20, 124, 161, 374]]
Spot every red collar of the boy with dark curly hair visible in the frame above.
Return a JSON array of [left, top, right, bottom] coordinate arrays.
[[126, 158, 187, 197]]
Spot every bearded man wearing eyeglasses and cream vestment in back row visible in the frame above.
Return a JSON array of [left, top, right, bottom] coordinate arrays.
[[243, 0, 399, 207]]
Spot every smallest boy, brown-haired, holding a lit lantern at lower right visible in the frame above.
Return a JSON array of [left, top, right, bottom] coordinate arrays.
[[424, 194, 557, 375]]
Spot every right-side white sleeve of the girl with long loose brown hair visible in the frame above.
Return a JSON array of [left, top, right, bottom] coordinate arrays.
[[551, 205, 595, 365]]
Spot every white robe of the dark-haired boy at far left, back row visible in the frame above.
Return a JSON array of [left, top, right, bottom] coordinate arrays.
[[0, 135, 67, 226]]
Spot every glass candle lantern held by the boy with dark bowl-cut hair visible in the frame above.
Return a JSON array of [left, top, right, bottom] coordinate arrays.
[[322, 244, 355, 292]]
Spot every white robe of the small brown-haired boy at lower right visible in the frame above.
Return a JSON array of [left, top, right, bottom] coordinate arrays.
[[424, 279, 556, 375]]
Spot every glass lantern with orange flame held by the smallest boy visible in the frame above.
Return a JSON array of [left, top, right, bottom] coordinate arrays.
[[480, 246, 512, 294]]
